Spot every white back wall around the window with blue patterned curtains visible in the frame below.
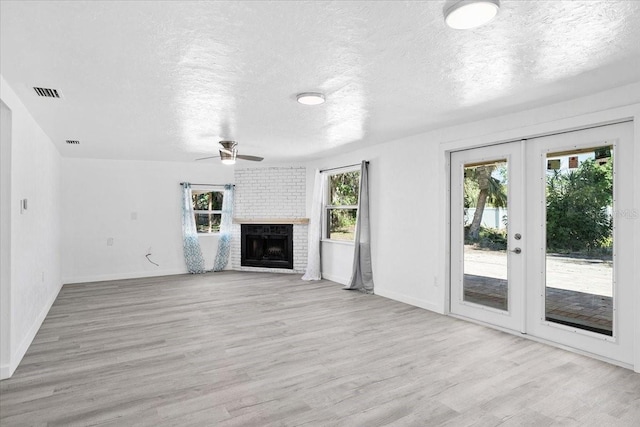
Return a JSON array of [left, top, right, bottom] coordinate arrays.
[[62, 158, 233, 283]]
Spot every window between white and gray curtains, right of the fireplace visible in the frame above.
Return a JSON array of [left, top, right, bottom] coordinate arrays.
[[323, 170, 360, 242]]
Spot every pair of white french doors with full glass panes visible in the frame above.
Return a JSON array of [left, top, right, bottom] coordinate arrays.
[[450, 123, 635, 365]]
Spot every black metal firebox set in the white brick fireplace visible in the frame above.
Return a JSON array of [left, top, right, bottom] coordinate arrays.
[[240, 224, 293, 269]]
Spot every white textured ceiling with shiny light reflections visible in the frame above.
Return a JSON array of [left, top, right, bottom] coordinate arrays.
[[0, 0, 640, 161]]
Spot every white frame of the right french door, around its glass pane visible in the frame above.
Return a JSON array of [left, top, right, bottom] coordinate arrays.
[[527, 122, 636, 366]]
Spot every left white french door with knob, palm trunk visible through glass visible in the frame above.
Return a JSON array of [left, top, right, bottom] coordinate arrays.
[[451, 142, 525, 330]]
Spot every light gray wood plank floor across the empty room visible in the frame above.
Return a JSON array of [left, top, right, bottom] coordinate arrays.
[[0, 272, 640, 427]]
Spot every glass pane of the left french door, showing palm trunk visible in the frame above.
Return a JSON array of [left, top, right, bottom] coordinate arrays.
[[463, 160, 509, 310]]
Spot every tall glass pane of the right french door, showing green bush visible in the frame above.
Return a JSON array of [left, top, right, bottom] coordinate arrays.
[[545, 146, 614, 335]]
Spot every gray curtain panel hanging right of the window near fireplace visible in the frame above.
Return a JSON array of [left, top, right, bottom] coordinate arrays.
[[344, 161, 373, 294]]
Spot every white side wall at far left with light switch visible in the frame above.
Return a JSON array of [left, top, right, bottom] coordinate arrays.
[[0, 76, 62, 378]]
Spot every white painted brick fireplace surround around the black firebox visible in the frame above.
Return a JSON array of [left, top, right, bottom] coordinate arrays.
[[231, 167, 308, 274]]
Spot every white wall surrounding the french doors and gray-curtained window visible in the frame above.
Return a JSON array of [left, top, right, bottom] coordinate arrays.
[[307, 83, 640, 318]]
